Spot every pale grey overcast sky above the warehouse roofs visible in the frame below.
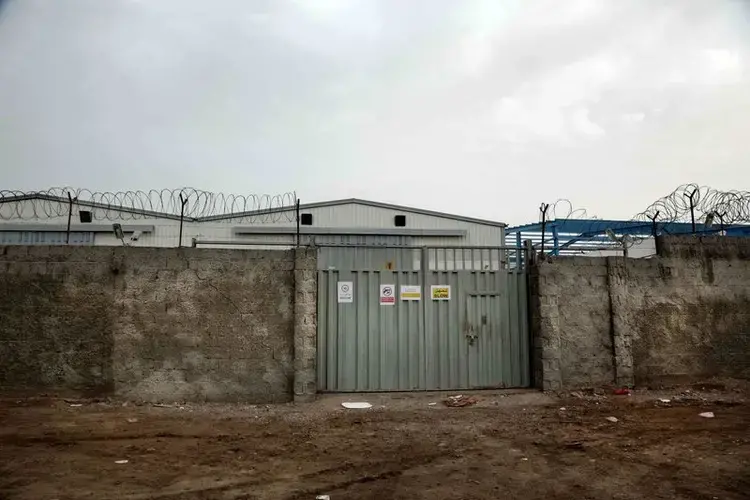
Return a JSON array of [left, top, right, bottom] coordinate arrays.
[[0, 0, 750, 223]]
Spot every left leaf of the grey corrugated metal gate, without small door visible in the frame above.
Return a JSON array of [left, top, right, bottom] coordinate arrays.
[[318, 270, 424, 392]]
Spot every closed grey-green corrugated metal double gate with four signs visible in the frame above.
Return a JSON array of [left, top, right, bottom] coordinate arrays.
[[318, 247, 530, 392]]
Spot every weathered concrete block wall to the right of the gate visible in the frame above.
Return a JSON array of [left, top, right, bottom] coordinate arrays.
[[530, 237, 750, 390]]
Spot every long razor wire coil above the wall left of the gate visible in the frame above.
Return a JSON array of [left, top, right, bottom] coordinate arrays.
[[0, 187, 297, 223]]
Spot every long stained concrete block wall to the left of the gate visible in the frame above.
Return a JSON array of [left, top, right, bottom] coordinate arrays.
[[0, 246, 316, 403]]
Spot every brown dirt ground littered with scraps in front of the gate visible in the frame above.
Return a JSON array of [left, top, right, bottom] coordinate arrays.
[[0, 384, 750, 500]]
